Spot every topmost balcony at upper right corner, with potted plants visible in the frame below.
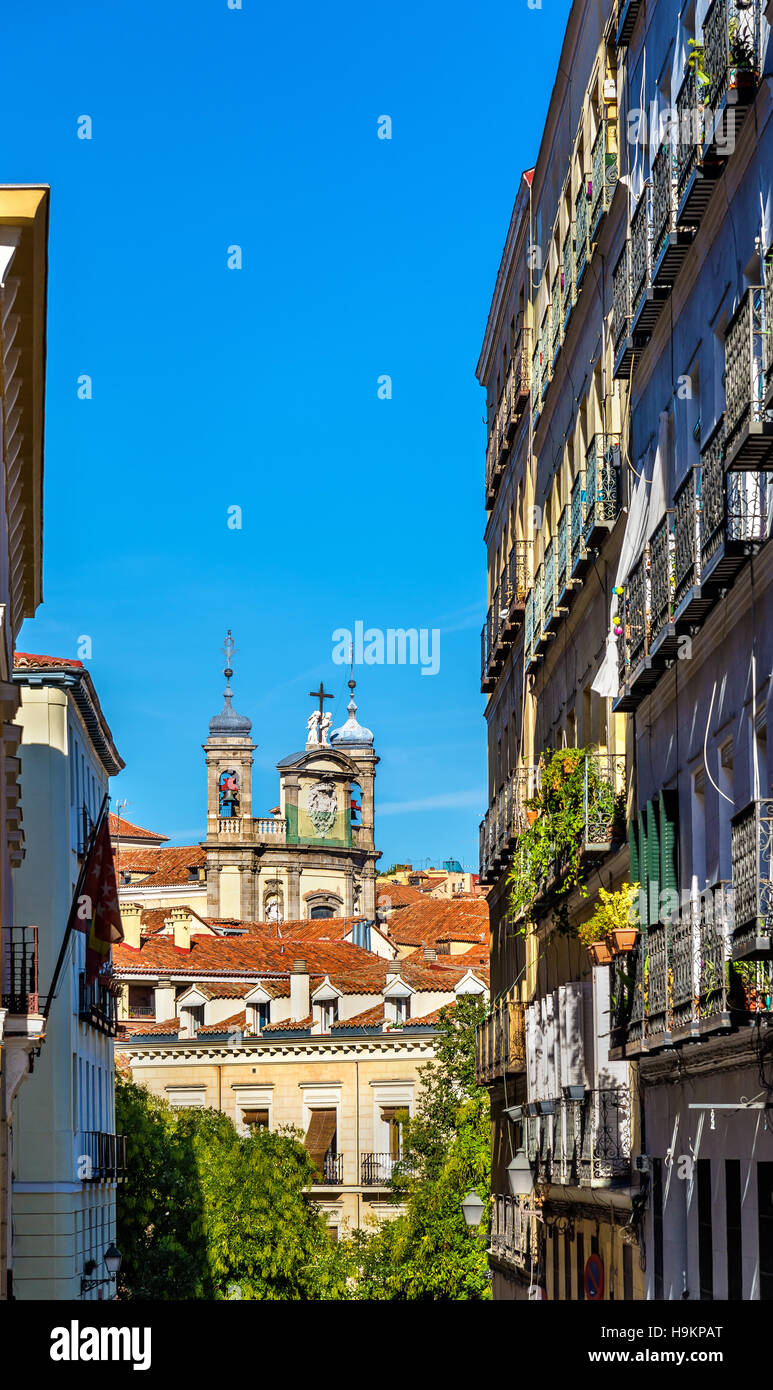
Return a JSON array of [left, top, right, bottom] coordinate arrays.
[[703, 0, 759, 145]]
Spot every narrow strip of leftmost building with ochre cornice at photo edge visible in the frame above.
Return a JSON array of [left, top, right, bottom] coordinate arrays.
[[0, 188, 49, 1298]]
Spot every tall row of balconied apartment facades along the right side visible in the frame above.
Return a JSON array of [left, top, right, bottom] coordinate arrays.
[[478, 0, 773, 1298]]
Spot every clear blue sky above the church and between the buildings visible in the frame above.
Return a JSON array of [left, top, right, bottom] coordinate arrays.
[[0, 0, 569, 867]]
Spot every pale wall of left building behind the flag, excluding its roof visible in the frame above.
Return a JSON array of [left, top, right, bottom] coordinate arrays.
[[14, 685, 115, 1300]]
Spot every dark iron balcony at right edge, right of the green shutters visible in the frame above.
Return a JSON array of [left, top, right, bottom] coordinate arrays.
[[730, 801, 773, 960]]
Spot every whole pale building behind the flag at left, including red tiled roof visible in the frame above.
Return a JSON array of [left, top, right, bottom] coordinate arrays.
[[13, 652, 124, 1301]]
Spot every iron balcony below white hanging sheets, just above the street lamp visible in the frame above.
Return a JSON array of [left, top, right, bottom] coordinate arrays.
[[526, 1086, 631, 1187]]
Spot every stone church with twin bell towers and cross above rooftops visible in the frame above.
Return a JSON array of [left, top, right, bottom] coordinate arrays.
[[203, 634, 380, 922]]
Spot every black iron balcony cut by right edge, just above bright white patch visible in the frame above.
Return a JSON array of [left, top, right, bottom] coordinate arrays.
[[724, 285, 773, 470]]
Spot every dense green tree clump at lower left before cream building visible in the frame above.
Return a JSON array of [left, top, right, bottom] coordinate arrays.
[[115, 1077, 346, 1300]]
